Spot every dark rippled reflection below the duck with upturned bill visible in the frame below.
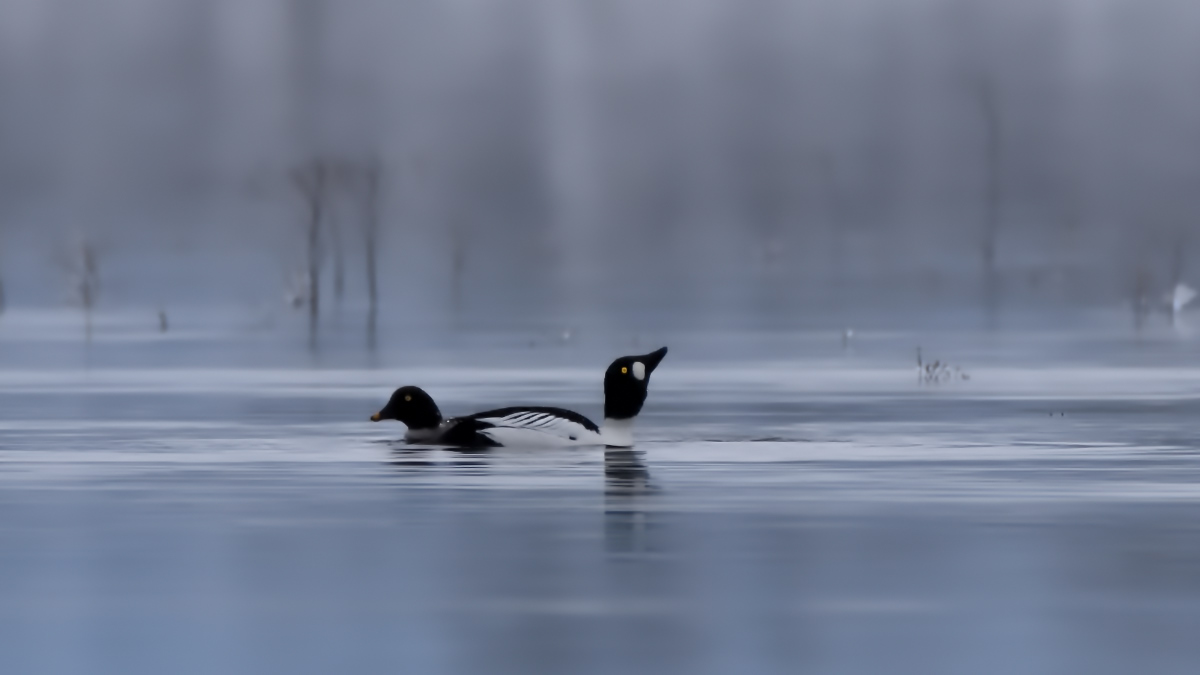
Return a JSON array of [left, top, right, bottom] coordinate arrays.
[[604, 449, 655, 554]]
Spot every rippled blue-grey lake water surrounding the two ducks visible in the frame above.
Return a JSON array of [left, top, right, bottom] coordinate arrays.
[[0, 309, 1200, 674]]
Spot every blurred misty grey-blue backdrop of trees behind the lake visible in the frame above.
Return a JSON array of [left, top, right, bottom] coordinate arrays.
[[0, 0, 1200, 324]]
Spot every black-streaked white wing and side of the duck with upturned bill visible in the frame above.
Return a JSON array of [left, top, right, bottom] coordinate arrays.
[[462, 407, 600, 446]]
